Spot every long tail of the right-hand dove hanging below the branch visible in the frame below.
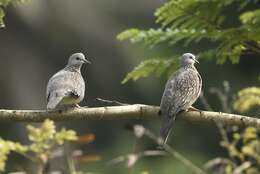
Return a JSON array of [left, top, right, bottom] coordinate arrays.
[[160, 116, 175, 145]]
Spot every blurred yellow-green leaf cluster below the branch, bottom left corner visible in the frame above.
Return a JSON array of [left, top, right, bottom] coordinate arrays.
[[0, 119, 78, 172]]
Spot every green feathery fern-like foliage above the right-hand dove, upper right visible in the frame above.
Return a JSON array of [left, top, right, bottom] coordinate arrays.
[[117, 0, 260, 83]]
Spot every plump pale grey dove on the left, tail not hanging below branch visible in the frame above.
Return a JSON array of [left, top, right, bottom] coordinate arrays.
[[46, 53, 90, 110]]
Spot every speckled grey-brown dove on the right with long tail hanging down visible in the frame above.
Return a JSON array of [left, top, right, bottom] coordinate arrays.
[[159, 53, 202, 144]]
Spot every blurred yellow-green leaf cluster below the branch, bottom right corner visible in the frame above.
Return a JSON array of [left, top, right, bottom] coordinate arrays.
[[206, 127, 260, 174]]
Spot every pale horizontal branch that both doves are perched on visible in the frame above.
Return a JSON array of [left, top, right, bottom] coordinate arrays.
[[0, 104, 260, 128]]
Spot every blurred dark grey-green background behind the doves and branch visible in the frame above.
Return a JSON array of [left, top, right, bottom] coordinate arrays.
[[0, 0, 260, 174]]
